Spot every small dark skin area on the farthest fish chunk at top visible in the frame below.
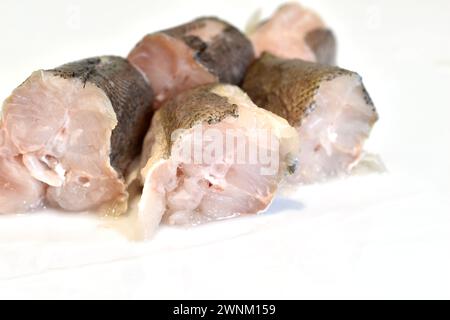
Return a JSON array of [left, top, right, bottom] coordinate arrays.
[[305, 29, 337, 65]]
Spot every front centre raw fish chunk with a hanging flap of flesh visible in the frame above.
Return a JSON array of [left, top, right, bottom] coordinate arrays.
[[138, 84, 298, 238]]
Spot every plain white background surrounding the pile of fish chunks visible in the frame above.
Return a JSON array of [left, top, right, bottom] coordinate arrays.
[[0, 0, 450, 299]]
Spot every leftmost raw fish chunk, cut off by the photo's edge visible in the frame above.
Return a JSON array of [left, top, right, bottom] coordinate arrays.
[[0, 56, 153, 213]]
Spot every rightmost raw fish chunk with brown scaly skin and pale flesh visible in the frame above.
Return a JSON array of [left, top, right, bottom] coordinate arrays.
[[243, 53, 378, 183]]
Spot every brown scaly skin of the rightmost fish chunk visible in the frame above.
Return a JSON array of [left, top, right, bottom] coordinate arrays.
[[243, 53, 378, 127]]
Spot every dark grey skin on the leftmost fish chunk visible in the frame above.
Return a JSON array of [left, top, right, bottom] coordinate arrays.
[[47, 56, 153, 175]]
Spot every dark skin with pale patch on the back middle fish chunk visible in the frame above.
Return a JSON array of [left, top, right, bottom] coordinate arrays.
[[162, 17, 255, 84]]
